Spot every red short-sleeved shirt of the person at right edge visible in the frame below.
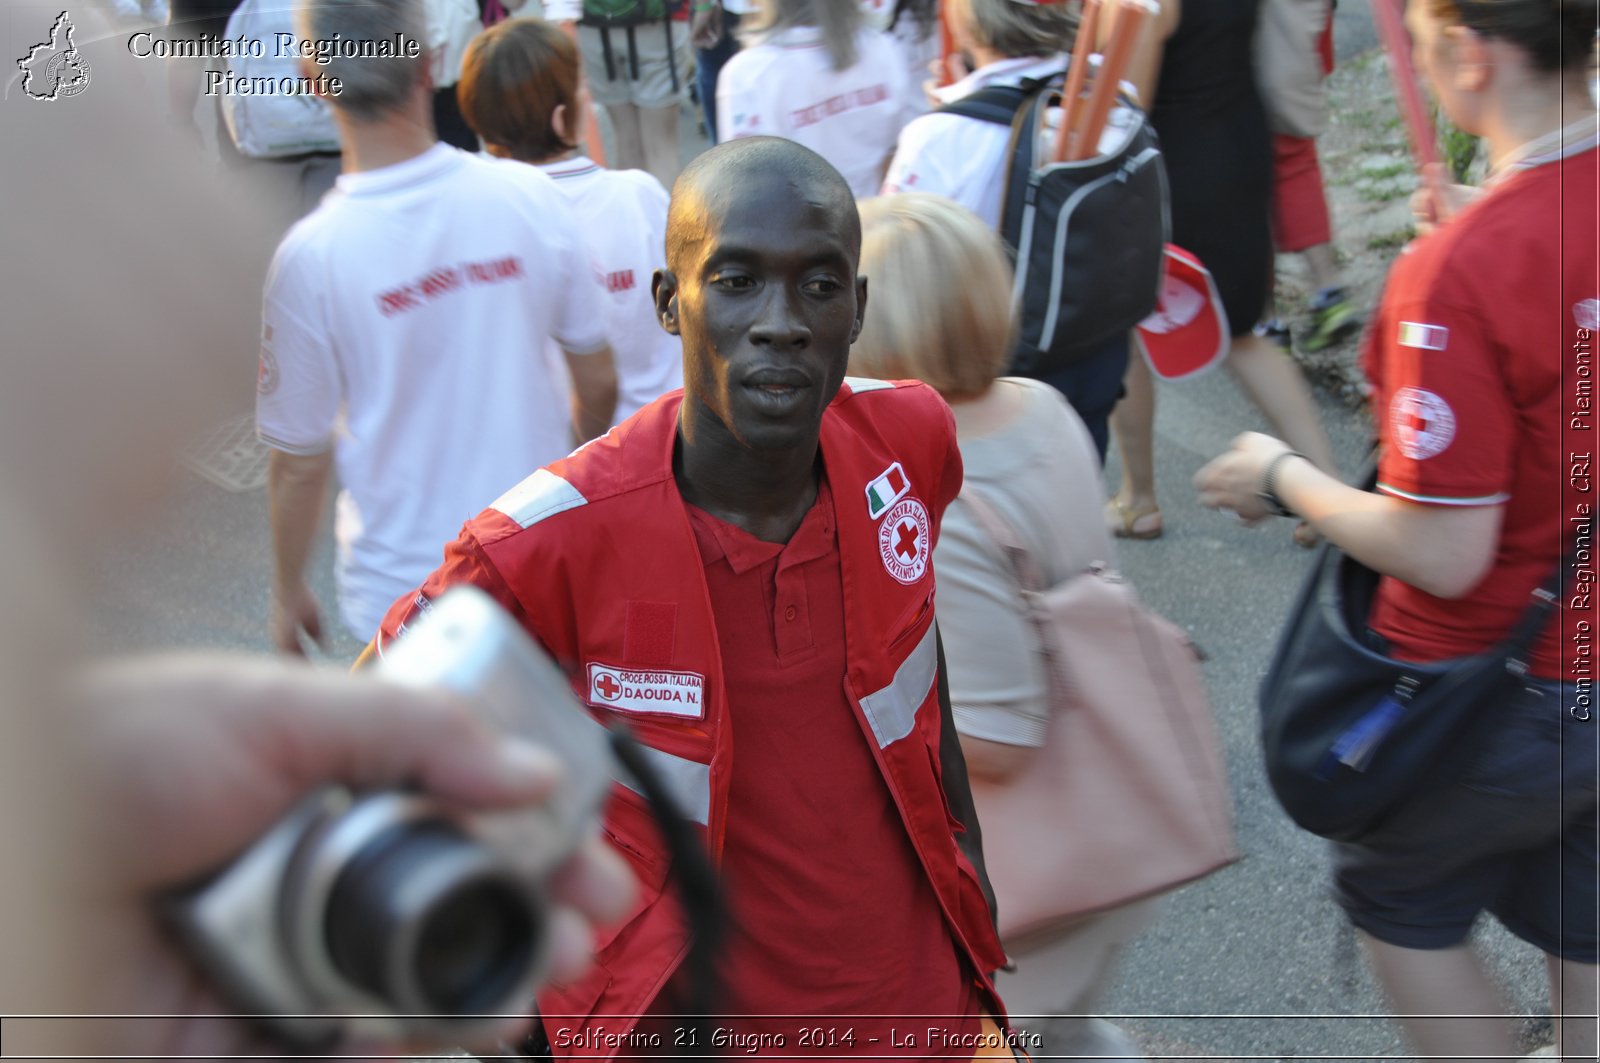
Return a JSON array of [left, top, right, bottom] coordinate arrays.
[[1366, 135, 1600, 677]]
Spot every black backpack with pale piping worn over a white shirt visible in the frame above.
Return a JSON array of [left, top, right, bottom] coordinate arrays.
[[939, 74, 1171, 376]]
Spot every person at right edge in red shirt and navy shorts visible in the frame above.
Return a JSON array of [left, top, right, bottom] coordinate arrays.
[[1195, 0, 1600, 1060]]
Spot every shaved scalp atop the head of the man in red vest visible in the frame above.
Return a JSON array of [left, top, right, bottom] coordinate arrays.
[[667, 136, 861, 272]]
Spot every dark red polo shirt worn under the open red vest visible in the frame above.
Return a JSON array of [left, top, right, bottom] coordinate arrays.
[[646, 482, 981, 1058]]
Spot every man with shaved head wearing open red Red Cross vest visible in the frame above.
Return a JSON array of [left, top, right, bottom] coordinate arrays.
[[378, 138, 1010, 1060]]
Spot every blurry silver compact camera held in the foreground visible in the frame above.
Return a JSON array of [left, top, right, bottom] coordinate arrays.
[[163, 588, 613, 1050]]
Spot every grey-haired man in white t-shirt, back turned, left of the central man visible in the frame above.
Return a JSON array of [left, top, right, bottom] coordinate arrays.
[[256, 0, 616, 653]]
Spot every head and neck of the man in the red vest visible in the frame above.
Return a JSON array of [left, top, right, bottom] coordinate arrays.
[[651, 136, 867, 464]]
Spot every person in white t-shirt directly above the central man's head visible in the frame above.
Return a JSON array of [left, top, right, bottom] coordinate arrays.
[[717, 0, 918, 200]]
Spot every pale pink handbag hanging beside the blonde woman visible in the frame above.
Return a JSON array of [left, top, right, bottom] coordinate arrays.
[[960, 491, 1238, 938]]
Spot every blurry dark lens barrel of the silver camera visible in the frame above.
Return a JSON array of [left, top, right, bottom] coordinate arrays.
[[325, 821, 544, 1015]]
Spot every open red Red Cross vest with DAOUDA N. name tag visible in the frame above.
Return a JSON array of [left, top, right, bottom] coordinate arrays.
[[378, 378, 1005, 1055]]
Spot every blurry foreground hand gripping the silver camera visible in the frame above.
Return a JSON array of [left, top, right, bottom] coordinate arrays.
[[72, 655, 632, 1057]]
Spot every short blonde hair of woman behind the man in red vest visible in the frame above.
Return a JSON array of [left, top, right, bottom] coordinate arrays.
[[850, 192, 1013, 399]]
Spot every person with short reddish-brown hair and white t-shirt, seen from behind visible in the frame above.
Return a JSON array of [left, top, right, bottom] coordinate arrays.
[[461, 19, 683, 423]]
